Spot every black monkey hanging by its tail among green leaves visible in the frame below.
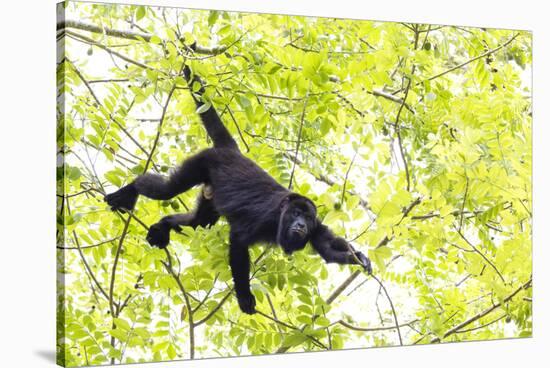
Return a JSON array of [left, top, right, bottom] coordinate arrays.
[[105, 66, 372, 314]]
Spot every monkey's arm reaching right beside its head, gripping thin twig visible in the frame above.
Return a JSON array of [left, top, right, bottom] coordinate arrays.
[[310, 222, 372, 274]]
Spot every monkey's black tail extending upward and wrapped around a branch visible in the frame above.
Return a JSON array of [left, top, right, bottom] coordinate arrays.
[[183, 65, 239, 150]]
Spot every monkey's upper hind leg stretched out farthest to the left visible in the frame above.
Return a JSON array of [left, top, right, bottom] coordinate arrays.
[[105, 150, 212, 210]]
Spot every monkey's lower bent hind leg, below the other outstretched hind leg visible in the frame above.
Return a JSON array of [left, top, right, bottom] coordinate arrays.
[[147, 193, 220, 249]]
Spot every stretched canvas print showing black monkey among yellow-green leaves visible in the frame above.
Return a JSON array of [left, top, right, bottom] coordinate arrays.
[[57, 1, 532, 366]]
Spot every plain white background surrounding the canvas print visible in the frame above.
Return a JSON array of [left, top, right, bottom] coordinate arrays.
[[0, 0, 550, 368]]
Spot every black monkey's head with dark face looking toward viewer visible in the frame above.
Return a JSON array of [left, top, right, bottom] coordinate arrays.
[[277, 193, 317, 255]]
